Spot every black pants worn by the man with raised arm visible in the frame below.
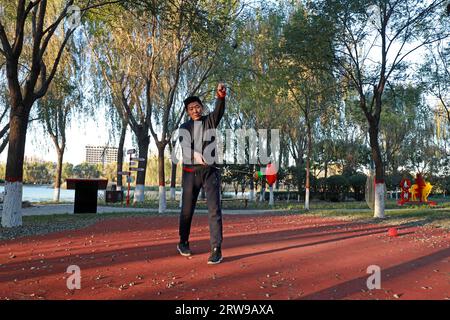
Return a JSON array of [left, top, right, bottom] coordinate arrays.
[[180, 167, 222, 247]]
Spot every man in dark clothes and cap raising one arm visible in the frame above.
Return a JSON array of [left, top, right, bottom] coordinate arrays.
[[177, 83, 226, 264]]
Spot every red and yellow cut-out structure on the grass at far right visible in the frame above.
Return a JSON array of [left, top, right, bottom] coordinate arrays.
[[397, 173, 437, 206]]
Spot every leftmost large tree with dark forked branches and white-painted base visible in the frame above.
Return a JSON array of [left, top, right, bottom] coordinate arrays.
[[0, 0, 122, 227]]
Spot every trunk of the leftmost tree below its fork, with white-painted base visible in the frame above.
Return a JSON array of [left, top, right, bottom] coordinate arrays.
[[2, 105, 30, 227]]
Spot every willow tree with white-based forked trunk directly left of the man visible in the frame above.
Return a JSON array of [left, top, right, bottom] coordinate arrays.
[[146, 0, 239, 212]]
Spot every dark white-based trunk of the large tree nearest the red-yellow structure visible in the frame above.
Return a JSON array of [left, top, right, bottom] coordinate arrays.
[[369, 121, 386, 218]]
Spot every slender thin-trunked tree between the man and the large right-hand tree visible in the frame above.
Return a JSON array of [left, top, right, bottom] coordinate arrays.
[[279, 7, 337, 210]]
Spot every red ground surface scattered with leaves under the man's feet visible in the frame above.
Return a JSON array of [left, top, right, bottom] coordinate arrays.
[[0, 214, 450, 300]]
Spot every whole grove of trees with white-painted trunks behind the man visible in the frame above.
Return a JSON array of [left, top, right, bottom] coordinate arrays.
[[0, 0, 450, 227]]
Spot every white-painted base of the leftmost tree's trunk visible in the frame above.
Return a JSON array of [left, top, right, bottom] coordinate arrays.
[[2, 181, 22, 228]]
